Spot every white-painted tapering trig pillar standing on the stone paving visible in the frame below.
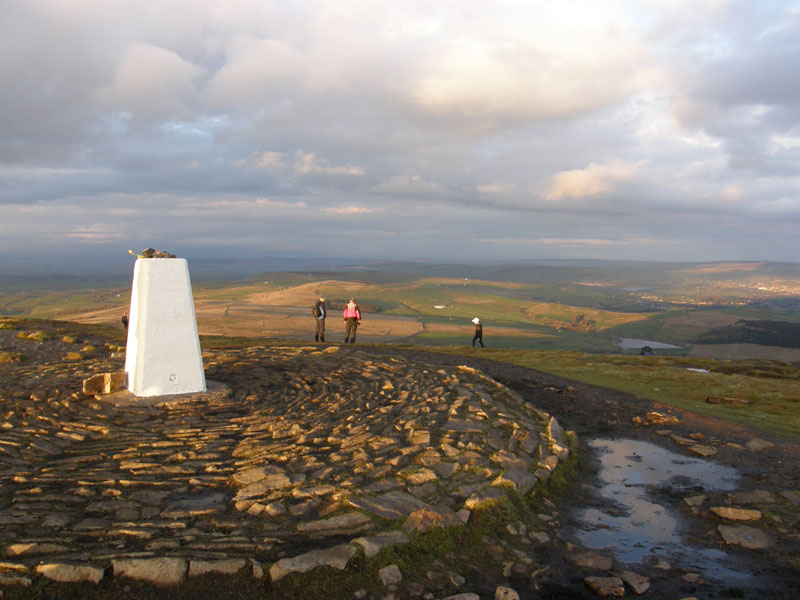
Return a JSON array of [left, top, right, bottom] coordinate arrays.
[[125, 258, 206, 396]]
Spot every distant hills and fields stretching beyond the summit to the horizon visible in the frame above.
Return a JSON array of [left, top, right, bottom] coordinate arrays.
[[6, 256, 800, 357]]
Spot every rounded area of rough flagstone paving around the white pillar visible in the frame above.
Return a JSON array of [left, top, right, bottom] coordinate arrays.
[[0, 346, 568, 584]]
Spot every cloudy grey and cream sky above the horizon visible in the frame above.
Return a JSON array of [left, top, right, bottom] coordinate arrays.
[[0, 0, 800, 261]]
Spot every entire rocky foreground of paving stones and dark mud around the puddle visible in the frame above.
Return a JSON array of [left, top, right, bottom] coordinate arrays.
[[0, 324, 800, 600]]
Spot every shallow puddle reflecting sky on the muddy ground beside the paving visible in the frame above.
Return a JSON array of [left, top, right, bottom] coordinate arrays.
[[575, 439, 749, 580]]
